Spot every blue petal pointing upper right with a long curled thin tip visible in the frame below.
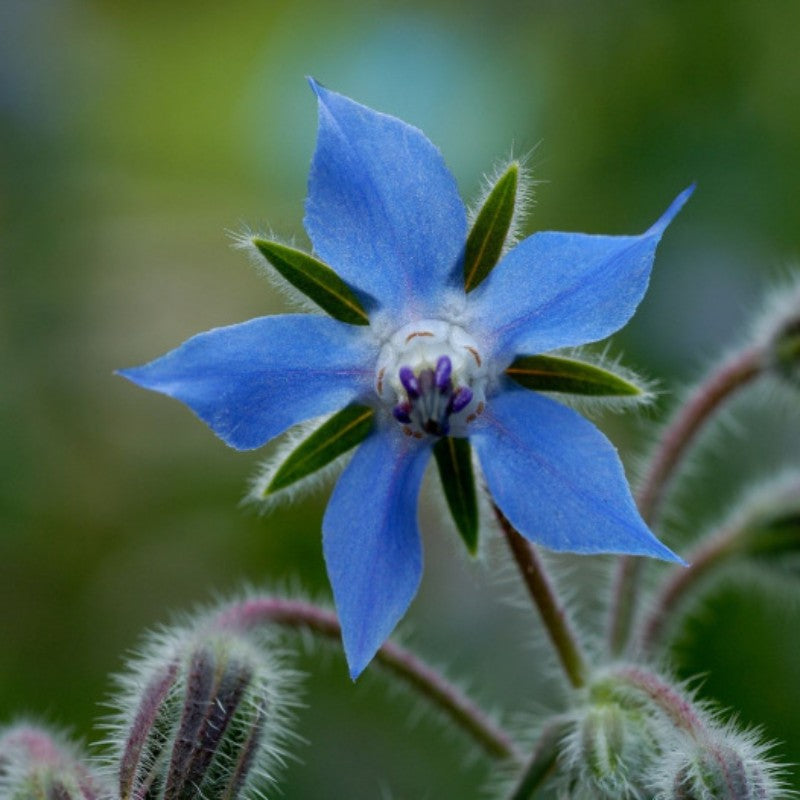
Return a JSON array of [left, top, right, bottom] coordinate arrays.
[[472, 186, 694, 357]]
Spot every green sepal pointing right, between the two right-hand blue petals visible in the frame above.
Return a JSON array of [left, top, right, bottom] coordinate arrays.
[[506, 355, 644, 397]]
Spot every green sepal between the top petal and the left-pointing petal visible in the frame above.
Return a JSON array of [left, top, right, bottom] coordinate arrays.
[[252, 238, 369, 325]]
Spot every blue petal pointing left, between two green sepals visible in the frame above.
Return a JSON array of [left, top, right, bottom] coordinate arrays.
[[119, 314, 376, 450]]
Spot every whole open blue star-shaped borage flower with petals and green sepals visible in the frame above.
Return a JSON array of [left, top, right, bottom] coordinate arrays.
[[122, 81, 691, 678]]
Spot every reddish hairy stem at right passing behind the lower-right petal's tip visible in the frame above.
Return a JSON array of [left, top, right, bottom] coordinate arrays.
[[608, 346, 765, 656]]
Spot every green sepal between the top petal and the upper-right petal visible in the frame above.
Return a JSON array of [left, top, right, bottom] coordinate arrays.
[[464, 161, 519, 292]]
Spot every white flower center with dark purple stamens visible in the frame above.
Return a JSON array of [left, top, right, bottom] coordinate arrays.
[[375, 320, 487, 439]]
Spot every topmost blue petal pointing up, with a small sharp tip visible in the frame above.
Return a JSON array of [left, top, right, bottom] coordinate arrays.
[[304, 80, 467, 313]]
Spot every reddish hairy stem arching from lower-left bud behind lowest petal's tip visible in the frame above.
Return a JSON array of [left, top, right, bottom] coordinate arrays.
[[215, 597, 522, 762]]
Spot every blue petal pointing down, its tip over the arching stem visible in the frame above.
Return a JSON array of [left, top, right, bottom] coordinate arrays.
[[322, 428, 431, 680]]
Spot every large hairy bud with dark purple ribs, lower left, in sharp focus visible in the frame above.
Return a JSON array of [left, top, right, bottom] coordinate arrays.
[[112, 627, 291, 800]]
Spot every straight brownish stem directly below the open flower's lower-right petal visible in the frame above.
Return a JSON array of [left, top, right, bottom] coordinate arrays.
[[492, 503, 588, 689]]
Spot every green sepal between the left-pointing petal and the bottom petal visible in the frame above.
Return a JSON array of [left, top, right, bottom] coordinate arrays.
[[264, 404, 375, 497]]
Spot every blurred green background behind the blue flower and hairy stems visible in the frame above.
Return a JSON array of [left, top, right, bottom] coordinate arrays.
[[0, 0, 800, 798]]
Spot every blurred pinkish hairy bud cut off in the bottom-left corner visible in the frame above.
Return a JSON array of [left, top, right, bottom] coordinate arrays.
[[0, 723, 111, 800]]
